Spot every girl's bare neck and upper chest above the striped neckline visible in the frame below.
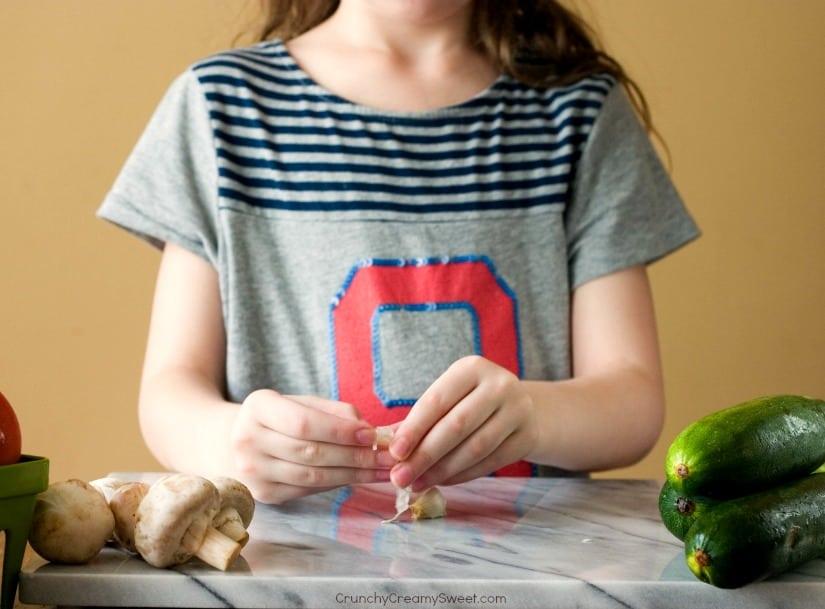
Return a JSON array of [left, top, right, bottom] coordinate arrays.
[[287, 0, 498, 111]]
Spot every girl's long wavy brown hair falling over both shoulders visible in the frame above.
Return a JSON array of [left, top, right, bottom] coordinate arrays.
[[241, 0, 655, 133]]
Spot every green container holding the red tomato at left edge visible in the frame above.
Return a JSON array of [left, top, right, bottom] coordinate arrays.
[[0, 455, 49, 609]]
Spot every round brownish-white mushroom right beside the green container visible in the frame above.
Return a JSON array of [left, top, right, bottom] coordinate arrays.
[[29, 479, 115, 564]]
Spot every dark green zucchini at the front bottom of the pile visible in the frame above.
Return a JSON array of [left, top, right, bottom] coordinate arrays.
[[685, 474, 825, 588]]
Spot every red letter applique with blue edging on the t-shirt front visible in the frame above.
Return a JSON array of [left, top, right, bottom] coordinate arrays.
[[330, 256, 521, 425]]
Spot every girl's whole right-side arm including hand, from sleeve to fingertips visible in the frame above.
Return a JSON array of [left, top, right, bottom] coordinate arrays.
[[390, 266, 664, 489]]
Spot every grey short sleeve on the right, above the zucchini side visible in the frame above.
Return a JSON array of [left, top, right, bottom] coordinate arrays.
[[565, 85, 699, 288]]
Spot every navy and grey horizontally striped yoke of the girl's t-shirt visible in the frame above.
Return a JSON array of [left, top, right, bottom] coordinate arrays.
[[193, 41, 614, 214]]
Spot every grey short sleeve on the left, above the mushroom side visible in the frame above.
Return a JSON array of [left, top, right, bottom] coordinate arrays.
[[97, 71, 218, 265]]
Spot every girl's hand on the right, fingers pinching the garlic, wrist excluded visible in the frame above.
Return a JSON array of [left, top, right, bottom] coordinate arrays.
[[389, 356, 538, 490]]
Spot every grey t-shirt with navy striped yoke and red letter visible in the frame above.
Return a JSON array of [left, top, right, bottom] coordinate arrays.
[[99, 41, 698, 442]]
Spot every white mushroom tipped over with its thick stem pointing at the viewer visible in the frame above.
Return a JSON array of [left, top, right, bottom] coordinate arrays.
[[135, 474, 241, 571]]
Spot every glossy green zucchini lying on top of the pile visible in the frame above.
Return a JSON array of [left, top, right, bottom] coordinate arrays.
[[665, 395, 825, 499]]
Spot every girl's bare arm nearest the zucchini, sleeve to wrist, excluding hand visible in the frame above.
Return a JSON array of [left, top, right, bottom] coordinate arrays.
[[528, 266, 665, 471]]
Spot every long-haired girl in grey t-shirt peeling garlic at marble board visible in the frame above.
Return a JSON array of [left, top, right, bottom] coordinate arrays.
[[99, 0, 697, 503]]
